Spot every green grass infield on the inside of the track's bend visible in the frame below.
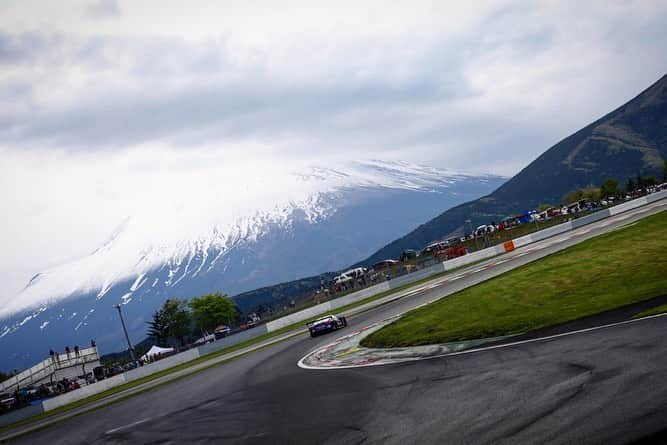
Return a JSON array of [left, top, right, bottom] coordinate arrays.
[[361, 212, 667, 347]]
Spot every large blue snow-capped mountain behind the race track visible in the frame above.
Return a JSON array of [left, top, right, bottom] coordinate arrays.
[[0, 161, 504, 369]]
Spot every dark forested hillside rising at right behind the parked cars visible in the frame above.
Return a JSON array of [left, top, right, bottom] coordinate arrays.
[[362, 75, 667, 264]]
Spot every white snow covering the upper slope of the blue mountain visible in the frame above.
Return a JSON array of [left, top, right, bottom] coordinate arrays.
[[0, 161, 488, 317]]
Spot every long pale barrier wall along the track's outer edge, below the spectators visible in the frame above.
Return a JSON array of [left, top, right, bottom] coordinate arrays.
[[0, 190, 667, 426]]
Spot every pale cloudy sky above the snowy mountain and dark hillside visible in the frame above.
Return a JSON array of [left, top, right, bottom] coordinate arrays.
[[0, 0, 667, 306]]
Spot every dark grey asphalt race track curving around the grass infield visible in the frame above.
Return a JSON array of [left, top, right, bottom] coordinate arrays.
[[6, 204, 667, 445]]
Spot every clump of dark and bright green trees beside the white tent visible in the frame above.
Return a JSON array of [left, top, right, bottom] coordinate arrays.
[[148, 293, 240, 347]]
